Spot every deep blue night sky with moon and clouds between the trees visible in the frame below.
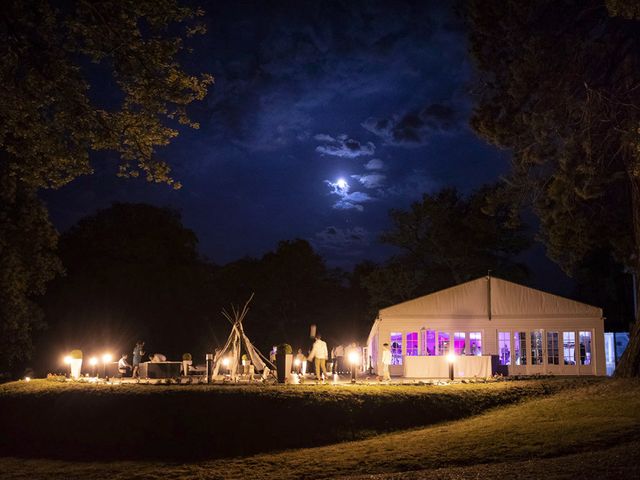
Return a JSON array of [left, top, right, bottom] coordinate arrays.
[[41, 1, 560, 284]]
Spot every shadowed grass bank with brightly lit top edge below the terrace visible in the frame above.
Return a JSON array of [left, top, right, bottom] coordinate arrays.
[[0, 379, 584, 460]]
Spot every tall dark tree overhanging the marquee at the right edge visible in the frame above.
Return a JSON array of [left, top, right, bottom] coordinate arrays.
[[468, 0, 640, 376]]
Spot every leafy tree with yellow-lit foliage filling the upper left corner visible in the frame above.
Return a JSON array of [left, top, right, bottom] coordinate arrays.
[[0, 0, 212, 372]]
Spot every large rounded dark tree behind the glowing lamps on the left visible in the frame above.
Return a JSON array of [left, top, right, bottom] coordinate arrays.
[[39, 203, 216, 372]]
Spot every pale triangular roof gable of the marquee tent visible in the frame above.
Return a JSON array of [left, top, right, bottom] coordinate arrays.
[[379, 277, 602, 318]]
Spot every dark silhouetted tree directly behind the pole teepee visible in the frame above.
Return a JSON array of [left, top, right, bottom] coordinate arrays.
[[216, 239, 363, 349]]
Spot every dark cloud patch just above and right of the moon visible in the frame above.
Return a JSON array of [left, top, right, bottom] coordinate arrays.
[[362, 103, 462, 146]]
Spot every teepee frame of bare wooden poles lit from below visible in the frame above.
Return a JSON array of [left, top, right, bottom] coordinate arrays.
[[213, 293, 275, 379]]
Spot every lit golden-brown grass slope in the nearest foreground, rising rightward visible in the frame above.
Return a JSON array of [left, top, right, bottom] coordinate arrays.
[[0, 381, 640, 479]]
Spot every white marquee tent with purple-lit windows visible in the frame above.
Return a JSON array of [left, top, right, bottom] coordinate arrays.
[[367, 277, 606, 378]]
